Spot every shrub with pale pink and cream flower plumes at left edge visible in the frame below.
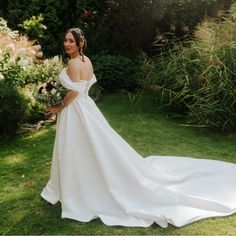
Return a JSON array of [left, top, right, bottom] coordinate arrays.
[[0, 18, 45, 86]]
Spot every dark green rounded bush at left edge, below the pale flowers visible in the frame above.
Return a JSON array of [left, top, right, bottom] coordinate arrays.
[[0, 80, 27, 135]]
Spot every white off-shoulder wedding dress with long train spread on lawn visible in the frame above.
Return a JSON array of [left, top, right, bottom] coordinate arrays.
[[41, 69, 236, 227]]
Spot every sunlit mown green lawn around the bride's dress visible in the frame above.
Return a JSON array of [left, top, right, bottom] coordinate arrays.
[[0, 94, 236, 235]]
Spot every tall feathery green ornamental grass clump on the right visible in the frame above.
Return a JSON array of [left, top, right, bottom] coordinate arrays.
[[143, 4, 236, 132]]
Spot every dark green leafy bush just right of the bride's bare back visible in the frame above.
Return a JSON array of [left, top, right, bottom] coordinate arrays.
[[92, 55, 140, 90]]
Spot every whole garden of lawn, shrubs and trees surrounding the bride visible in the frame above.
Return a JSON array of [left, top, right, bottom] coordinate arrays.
[[0, 0, 236, 235]]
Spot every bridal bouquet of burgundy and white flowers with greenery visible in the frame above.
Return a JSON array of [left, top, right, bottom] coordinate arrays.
[[35, 80, 67, 106]]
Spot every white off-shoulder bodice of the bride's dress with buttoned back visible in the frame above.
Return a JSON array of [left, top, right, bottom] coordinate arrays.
[[59, 68, 97, 98]]
